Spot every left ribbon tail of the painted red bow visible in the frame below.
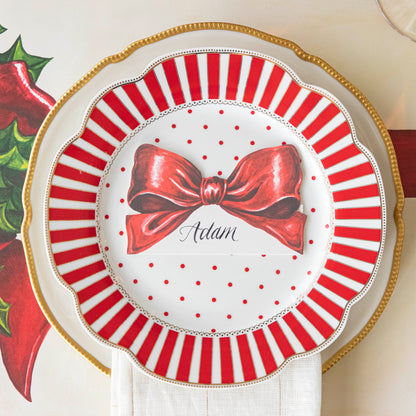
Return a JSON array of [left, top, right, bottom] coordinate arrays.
[[126, 209, 195, 254]]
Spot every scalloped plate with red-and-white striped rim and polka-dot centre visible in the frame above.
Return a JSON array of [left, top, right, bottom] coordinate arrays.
[[46, 48, 386, 386]]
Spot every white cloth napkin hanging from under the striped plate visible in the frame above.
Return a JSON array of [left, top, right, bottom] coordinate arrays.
[[111, 351, 321, 416]]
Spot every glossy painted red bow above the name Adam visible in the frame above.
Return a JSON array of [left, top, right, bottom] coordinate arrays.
[[126, 144, 306, 254]]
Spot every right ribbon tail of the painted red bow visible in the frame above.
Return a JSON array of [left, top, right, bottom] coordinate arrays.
[[222, 207, 306, 254]]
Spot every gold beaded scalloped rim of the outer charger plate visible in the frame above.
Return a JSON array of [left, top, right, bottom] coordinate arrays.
[[22, 22, 404, 376]]
